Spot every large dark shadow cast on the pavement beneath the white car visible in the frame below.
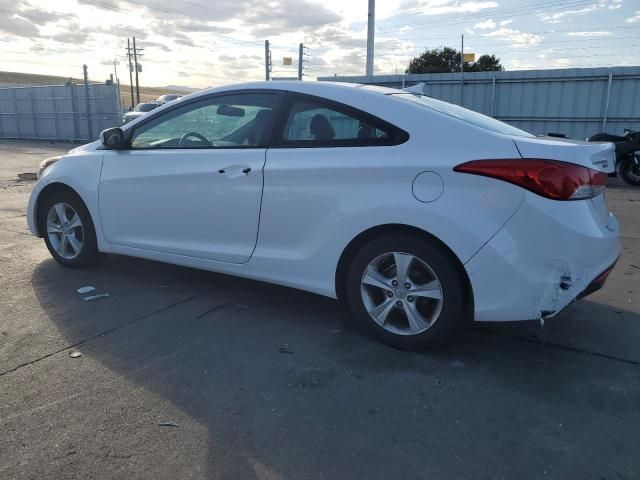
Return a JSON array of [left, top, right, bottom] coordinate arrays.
[[27, 256, 640, 479]]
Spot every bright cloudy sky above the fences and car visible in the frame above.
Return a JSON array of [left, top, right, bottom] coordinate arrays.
[[0, 0, 640, 88]]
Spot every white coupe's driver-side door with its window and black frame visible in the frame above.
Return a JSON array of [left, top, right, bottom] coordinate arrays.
[[99, 91, 280, 263]]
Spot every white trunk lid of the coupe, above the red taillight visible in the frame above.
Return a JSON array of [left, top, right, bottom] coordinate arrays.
[[513, 137, 616, 173]]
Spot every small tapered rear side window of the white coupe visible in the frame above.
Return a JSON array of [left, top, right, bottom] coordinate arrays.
[[279, 97, 406, 147]]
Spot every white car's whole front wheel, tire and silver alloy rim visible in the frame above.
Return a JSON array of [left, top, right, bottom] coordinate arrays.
[[39, 191, 102, 268]]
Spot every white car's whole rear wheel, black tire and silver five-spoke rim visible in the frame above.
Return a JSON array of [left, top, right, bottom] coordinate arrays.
[[346, 235, 466, 350]]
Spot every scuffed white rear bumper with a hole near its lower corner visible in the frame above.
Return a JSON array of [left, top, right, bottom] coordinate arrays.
[[465, 193, 620, 321]]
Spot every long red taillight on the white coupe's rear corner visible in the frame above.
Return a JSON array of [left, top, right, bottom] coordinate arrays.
[[454, 158, 607, 200]]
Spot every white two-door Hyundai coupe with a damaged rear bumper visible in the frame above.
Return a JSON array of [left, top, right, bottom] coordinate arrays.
[[28, 82, 620, 349]]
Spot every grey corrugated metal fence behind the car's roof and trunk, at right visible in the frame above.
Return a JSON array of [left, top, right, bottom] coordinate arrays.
[[318, 67, 640, 139]]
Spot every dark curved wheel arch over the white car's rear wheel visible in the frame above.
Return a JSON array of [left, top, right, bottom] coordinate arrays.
[[335, 223, 474, 318]]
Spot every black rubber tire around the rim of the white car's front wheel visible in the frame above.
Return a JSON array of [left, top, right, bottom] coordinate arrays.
[[38, 191, 104, 268]]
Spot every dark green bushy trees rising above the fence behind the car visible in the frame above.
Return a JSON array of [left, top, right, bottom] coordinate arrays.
[[406, 47, 504, 73]]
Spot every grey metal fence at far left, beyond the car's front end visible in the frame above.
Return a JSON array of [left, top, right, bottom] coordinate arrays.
[[0, 84, 120, 140]]
